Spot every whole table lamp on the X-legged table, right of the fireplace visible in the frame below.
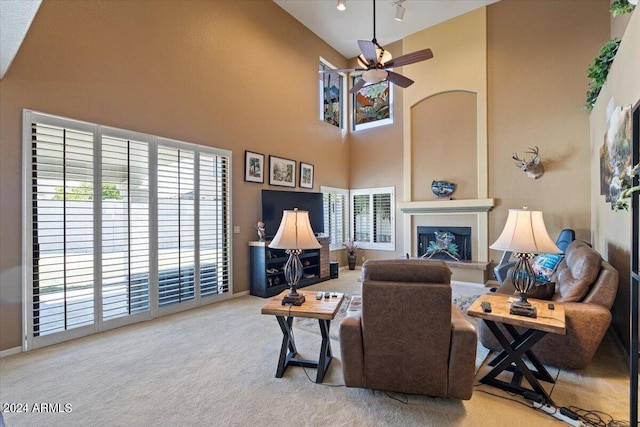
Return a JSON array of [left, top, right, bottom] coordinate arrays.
[[489, 208, 562, 317]]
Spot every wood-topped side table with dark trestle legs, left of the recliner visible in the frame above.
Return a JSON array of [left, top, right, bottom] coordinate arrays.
[[262, 289, 344, 383]]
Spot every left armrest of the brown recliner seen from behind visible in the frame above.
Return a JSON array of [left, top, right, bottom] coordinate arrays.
[[339, 296, 364, 387]]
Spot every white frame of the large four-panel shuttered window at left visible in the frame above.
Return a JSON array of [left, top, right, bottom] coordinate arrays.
[[22, 110, 233, 351]]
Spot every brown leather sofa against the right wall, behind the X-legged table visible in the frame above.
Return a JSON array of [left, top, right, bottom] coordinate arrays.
[[478, 240, 618, 369]]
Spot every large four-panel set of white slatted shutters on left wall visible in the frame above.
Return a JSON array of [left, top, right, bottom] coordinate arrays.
[[24, 111, 233, 348]]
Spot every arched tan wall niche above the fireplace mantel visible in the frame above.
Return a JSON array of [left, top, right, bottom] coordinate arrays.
[[411, 90, 479, 200]]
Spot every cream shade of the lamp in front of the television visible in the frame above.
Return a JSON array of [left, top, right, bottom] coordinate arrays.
[[269, 209, 321, 249]]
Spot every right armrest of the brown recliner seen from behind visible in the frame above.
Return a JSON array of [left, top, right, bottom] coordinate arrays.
[[448, 305, 478, 400]]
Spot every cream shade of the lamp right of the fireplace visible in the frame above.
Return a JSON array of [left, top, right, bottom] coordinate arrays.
[[490, 209, 562, 254]]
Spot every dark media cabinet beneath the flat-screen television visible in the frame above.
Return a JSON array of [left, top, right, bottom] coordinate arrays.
[[249, 237, 330, 298]]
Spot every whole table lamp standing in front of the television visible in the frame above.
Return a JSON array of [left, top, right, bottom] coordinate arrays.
[[269, 209, 321, 305]]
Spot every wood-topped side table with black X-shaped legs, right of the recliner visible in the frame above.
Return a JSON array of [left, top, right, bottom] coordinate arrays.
[[467, 293, 566, 405]]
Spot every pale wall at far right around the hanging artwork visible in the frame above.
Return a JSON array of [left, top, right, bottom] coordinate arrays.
[[590, 9, 640, 354]]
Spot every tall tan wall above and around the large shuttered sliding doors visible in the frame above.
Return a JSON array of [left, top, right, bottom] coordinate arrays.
[[0, 0, 350, 350]]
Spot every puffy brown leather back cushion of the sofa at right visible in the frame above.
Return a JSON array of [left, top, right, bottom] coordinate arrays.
[[553, 240, 602, 302]]
